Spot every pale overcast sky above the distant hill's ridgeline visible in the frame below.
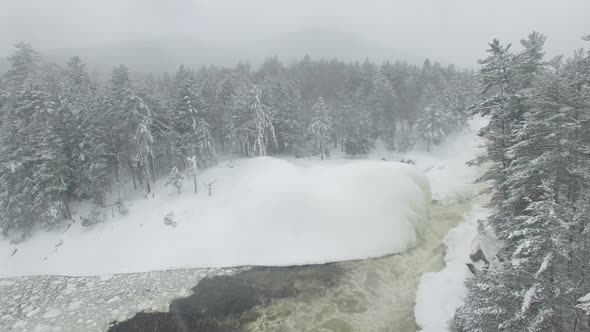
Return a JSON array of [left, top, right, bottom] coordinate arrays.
[[0, 0, 590, 66]]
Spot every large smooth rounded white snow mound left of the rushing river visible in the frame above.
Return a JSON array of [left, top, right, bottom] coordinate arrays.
[[0, 158, 430, 277]]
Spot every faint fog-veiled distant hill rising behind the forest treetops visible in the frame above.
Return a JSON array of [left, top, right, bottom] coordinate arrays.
[[0, 29, 423, 76]]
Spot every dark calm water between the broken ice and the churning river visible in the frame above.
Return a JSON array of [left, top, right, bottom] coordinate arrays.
[[109, 264, 344, 332]]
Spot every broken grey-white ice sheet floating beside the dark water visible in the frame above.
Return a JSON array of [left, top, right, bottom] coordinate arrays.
[[0, 269, 238, 332]]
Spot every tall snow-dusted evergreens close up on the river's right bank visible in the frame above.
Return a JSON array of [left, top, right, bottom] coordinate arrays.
[[454, 33, 590, 332]]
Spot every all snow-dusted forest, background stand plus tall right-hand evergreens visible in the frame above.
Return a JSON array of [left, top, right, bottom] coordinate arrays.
[[0, 27, 590, 332]]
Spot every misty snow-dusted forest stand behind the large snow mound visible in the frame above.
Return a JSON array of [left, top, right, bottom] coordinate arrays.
[[0, 43, 479, 237]]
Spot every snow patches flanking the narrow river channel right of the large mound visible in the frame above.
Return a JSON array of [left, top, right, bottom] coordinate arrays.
[[414, 118, 497, 332]]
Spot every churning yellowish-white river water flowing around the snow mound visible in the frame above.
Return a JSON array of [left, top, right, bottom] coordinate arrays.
[[247, 201, 470, 332]]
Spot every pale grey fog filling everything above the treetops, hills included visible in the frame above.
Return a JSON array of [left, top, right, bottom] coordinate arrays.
[[0, 0, 590, 69]]
